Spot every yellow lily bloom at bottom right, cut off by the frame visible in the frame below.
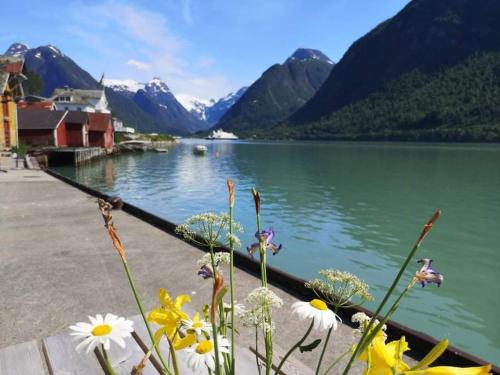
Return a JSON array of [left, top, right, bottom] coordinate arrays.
[[359, 332, 491, 375]]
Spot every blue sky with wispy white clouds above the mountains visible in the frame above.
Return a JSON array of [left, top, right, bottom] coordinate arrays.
[[0, 0, 409, 100]]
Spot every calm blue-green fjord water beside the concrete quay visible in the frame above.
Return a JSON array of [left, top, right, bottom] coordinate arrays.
[[57, 140, 500, 364]]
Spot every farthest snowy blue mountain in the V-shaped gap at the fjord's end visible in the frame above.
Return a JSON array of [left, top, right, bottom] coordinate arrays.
[[180, 87, 248, 125]]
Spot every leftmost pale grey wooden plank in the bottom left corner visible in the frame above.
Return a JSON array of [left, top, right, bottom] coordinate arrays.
[[0, 340, 45, 375]]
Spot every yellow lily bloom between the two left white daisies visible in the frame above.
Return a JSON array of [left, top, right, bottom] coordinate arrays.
[[148, 288, 196, 350]]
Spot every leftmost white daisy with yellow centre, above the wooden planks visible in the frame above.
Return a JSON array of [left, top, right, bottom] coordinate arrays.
[[69, 314, 134, 354]]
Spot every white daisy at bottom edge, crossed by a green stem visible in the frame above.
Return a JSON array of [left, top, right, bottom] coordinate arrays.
[[186, 335, 230, 374]]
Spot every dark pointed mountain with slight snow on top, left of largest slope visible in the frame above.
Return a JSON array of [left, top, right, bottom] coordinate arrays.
[[216, 48, 335, 132]]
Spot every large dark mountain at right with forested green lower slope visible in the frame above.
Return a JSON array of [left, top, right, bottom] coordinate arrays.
[[288, 0, 500, 140]]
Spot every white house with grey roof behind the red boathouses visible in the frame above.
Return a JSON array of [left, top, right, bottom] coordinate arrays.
[[51, 88, 111, 113]]
